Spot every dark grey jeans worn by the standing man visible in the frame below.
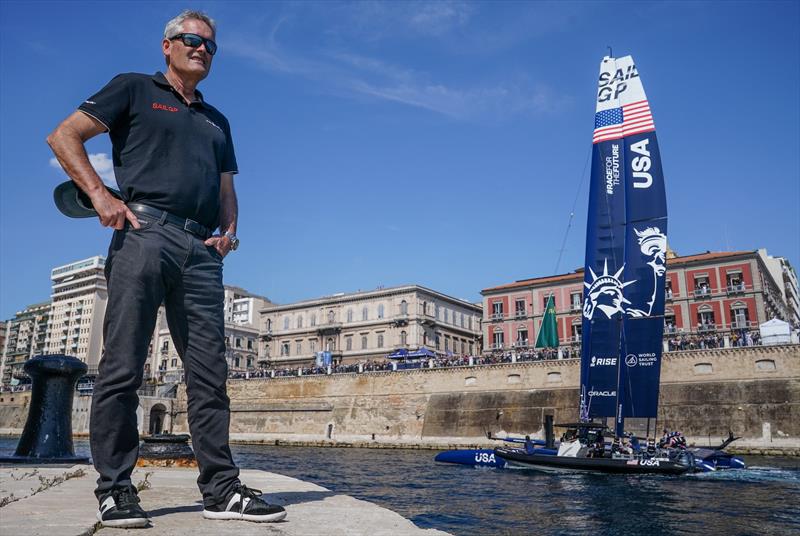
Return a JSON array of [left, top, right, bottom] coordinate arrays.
[[90, 217, 239, 505]]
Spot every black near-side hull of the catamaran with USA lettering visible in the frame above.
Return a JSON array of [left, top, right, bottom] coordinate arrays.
[[494, 448, 693, 475]]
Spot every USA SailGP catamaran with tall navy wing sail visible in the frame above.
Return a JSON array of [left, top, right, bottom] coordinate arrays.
[[436, 56, 744, 474]]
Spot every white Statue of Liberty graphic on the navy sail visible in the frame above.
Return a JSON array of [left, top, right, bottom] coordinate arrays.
[[583, 227, 667, 320]]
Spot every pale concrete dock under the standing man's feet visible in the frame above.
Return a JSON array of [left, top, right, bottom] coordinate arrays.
[[0, 465, 447, 536]]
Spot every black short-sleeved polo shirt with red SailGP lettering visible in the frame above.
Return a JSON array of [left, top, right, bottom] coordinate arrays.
[[78, 72, 238, 229]]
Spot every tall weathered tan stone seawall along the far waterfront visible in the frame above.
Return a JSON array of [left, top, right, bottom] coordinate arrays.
[[170, 345, 800, 450]]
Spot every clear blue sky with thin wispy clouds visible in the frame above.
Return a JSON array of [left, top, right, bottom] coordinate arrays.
[[0, 1, 800, 318]]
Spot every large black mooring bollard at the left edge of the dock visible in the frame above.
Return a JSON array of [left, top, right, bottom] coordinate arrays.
[[0, 354, 89, 464]]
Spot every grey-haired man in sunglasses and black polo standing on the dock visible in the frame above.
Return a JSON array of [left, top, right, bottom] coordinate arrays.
[[47, 11, 286, 527]]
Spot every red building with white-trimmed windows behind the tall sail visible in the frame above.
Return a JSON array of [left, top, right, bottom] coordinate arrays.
[[481, 249, 792, 352]]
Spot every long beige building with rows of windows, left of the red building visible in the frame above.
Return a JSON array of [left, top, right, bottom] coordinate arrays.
[[259, 285, 481, 367]]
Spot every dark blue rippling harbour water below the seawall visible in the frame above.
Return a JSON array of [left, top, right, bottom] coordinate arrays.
[[0, 438, 800, 536]]
